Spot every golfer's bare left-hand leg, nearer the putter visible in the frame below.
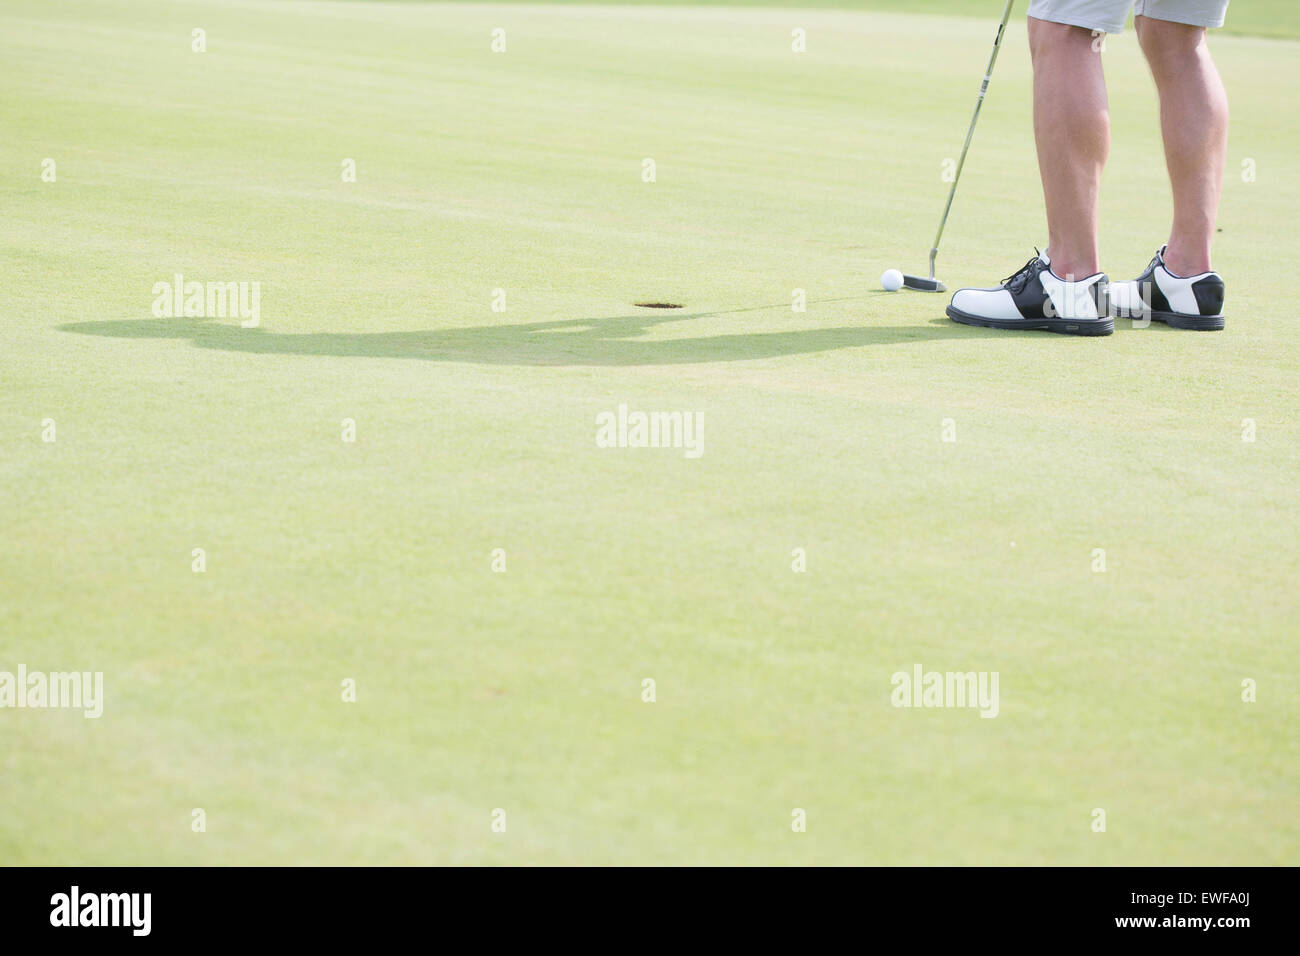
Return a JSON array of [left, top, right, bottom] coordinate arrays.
[[1030, 17, 1110, 278]]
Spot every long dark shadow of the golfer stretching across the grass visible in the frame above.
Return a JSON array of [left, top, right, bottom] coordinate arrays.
[[59, 304, 985, 365]]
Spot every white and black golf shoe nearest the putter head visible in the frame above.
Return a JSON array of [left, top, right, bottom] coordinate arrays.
[[948, 252, 1115, 336]]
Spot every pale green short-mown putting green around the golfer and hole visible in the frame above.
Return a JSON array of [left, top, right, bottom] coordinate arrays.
[[0, 0, 1300, 866]]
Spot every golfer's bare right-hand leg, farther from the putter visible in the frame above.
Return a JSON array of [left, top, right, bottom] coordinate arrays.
[[1138, 17, 1227, 276]]
